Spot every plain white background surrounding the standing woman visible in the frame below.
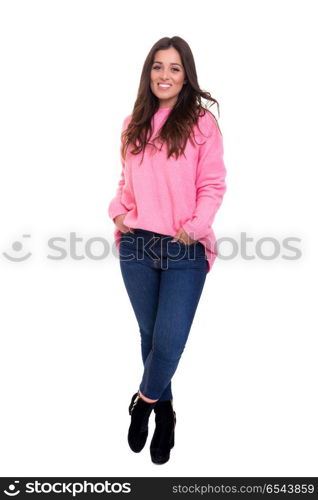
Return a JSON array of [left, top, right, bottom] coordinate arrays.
[[0, 0, 318, 477]]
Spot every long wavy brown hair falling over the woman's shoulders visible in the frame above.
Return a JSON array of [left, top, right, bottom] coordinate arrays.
[[121, 36, 220, 159]]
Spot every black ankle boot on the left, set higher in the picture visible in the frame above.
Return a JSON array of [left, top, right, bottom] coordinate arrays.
[[128, 392, 156, 453]]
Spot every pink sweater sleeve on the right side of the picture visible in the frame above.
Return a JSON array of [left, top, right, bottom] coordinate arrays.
[[182, 113, 226, 240]]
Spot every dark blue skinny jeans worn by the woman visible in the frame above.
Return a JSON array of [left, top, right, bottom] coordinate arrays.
[[119, 229, 208, 401]]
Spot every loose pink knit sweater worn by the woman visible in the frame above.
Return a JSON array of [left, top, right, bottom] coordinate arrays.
[[108, 107, 226, 271]]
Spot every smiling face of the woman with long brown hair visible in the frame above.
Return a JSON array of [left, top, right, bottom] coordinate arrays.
[[150, 47, 186, 108]]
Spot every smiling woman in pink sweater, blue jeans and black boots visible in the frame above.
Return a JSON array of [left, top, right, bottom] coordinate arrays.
[[108, 36, 226, 464]]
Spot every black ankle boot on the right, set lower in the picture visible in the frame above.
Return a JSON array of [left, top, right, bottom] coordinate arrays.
[[150, 399, 177, 464]]
